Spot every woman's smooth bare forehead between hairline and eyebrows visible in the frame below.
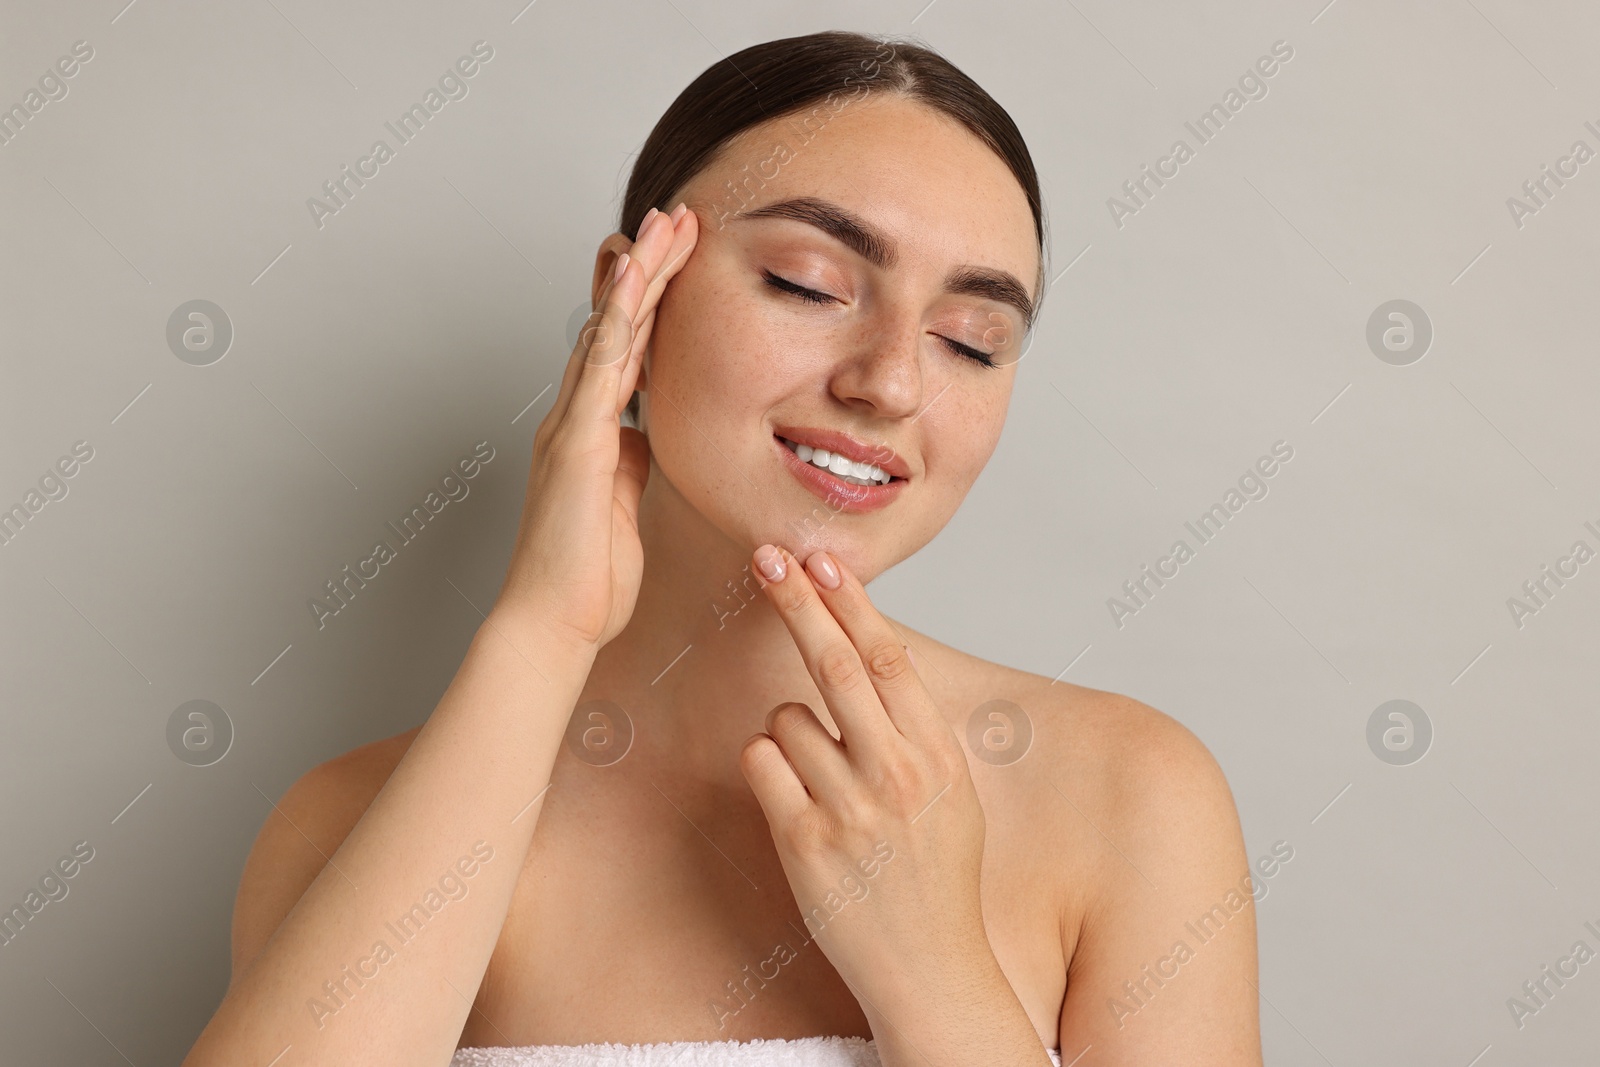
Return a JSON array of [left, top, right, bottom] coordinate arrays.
[[683, 91, 1038, 299]]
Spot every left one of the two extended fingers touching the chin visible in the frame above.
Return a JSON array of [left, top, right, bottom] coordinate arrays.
[[755, 545, 893, 753]]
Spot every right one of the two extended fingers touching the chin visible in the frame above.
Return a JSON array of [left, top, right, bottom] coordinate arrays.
[[805, 549, 944, 737]]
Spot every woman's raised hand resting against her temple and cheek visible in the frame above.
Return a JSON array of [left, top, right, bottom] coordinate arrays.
[[496, 205, 699, 653]]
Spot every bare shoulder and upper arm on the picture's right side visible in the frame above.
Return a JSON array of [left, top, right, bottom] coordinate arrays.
[[899, 627, 1261, 1067]]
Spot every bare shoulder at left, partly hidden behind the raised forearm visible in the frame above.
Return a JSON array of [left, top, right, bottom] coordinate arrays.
[[234, 726, 421, 981]]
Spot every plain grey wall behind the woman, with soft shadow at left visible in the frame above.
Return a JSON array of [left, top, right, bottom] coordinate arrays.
[[0, 0, 1600, 1067]]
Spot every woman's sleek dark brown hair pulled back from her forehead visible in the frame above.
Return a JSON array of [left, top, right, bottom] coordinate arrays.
[[618, 30, 1045, 426]]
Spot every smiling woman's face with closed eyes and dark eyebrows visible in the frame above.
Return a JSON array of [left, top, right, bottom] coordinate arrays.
[[638, 93, 1040, 579]]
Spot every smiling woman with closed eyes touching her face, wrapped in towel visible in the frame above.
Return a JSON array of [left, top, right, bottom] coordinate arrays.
[[186, 34, 1261, 1067]]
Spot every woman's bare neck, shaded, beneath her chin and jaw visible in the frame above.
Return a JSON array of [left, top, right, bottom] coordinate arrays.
[[582, 464, 832, 790]]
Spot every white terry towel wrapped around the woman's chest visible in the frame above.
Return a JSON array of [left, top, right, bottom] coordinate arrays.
[[450, 1037, 1061, 1067]]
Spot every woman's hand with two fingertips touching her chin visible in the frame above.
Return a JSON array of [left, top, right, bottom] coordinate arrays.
[[741, 545, 994, 1014]]
